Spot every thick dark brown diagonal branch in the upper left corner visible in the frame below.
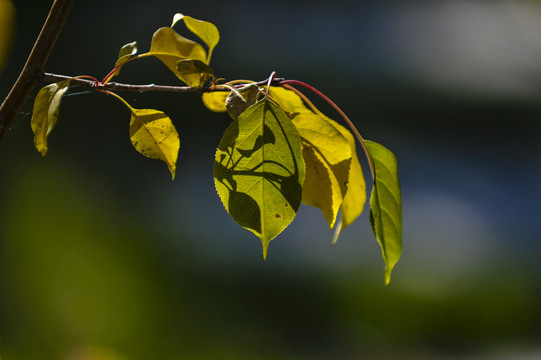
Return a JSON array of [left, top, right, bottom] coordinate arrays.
[[0, 0, 75, 142]]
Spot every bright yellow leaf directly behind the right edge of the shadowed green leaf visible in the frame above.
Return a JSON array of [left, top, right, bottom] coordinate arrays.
[[270, 87, 357, 229]]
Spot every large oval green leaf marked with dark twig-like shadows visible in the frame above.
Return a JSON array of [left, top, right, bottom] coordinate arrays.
[[214, 99, 305, 258]]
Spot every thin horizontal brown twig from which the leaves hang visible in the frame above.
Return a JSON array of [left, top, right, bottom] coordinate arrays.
[[40, 73, 284, 93]]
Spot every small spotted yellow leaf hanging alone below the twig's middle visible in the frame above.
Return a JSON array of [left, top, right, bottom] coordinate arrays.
[[126, 104, 180, 179]]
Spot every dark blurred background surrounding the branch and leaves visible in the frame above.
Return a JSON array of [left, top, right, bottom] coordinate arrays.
[[0, 0, 541, 360]]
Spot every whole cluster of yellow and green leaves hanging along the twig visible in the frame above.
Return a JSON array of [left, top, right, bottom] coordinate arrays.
[[31, 14, 402, 283]]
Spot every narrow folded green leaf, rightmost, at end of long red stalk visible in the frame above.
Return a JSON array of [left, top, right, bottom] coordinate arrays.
[[364, 140, 402, 285]]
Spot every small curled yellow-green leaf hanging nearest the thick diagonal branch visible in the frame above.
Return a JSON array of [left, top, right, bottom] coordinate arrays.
[[30, 80, 70, 156]]
